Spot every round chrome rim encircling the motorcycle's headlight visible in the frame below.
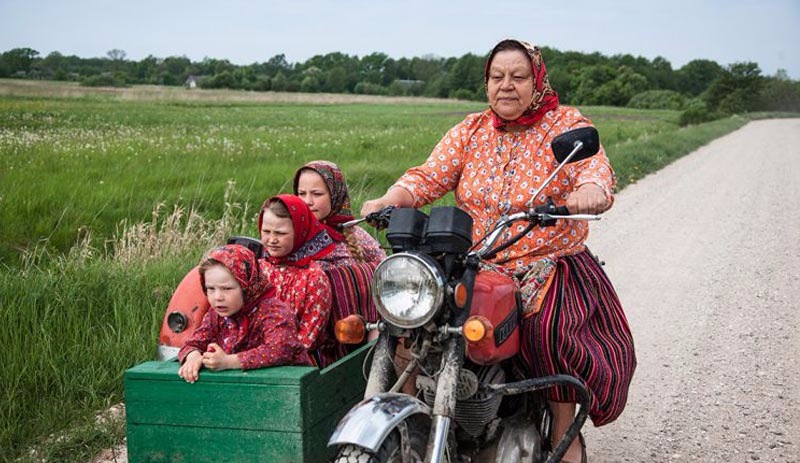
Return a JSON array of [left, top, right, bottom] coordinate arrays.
[[372, 252, 446, 329]]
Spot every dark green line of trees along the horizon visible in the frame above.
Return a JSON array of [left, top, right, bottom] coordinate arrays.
[[0, 47, 800, 123]]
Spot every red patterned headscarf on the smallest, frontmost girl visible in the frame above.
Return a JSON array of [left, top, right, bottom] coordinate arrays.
[[200, 244, 274, 313]]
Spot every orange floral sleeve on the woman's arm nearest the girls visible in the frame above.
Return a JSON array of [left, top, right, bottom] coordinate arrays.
[[393, 116, 472, 208]]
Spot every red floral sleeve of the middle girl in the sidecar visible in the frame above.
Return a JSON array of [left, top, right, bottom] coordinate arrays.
[[298, 264, 332, 349]]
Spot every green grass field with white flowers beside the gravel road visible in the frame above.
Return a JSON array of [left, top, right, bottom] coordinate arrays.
[[0, 80, 746, 461]]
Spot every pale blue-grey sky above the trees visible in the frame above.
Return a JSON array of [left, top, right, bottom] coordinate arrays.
[[0, 0, 800, 80]]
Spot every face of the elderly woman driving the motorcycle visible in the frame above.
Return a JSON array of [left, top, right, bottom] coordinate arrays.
[[486, 50, 533, 121]]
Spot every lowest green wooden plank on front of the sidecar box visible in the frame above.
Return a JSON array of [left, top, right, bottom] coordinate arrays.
[[127, 424, 304, 463]]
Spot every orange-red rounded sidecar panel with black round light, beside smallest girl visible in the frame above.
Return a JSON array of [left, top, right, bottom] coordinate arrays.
[[157, 267, 209, 360]]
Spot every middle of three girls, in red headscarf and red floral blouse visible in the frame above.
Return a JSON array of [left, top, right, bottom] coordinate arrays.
[[258, 194, 334, 367]]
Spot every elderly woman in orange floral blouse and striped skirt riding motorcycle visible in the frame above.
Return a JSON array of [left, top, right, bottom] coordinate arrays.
[[361, 40, 636, 461]]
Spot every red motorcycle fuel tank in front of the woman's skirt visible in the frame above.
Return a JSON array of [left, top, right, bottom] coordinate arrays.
[[467, 271, 520, 365]]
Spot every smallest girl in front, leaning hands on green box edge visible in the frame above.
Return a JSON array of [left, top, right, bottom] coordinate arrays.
[[178, 245, 311, 383]]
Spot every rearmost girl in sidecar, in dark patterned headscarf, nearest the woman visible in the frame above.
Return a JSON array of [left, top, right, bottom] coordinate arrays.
[[294, 161, 386, 269]]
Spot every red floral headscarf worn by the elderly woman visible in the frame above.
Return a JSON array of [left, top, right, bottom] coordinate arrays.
[[483, 39, 558, 128]]
